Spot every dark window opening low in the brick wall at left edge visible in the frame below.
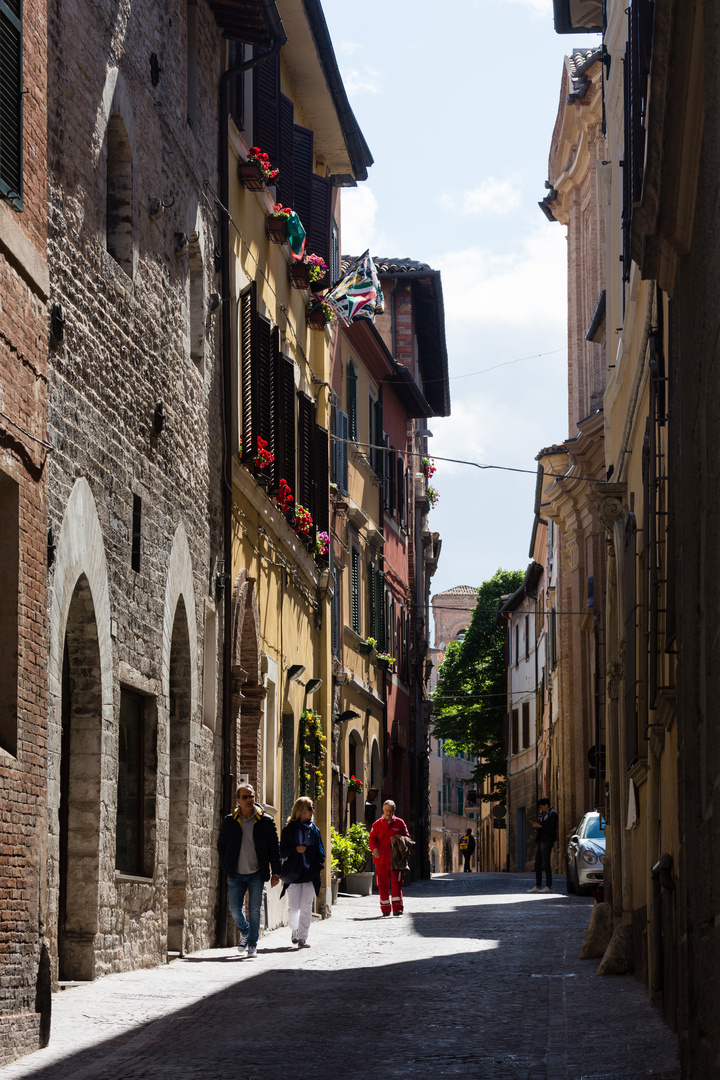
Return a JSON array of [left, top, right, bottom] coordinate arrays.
[[0, 472, 19, 755]]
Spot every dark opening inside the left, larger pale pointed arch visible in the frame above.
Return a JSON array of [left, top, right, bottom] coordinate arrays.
[[57, 575, 103, 980]]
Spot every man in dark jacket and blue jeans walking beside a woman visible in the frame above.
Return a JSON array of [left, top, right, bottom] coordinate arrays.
[[217, 784, 280, 956]]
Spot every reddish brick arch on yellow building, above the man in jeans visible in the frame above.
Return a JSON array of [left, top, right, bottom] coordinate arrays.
[[232, 569, 267, 791]]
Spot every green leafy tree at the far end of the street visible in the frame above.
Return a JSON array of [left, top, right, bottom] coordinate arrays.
[[433, 570, 525, 802]]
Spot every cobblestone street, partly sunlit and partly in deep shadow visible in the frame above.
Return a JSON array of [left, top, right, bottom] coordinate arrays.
[[0, 874, 680, 1080]]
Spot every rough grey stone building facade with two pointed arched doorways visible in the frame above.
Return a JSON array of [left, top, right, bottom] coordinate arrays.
[[47, 0, 227, 981]]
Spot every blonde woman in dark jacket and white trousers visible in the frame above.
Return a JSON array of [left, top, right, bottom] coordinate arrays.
[[280, 795, 325, 948]]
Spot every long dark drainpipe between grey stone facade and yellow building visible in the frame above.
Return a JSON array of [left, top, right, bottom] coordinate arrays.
[[217, 14, 287, 947]]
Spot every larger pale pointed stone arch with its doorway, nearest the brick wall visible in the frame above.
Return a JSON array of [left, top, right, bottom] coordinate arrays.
[[47, 477, 116, 980]]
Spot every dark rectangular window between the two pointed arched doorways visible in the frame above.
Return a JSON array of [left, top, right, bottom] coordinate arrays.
[[116, 688, 155, 877]]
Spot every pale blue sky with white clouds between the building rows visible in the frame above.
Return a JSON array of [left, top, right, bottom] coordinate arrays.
[[323, 0, 599, 595]]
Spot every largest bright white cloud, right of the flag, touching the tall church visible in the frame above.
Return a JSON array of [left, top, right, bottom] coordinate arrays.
[[431, 226, 568, 326]]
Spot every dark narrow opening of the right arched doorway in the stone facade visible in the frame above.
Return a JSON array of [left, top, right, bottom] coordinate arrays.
[[167, 597, 192, 955]]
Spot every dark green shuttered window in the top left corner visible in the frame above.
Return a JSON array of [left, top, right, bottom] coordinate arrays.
[[0, 0, 23, 210]]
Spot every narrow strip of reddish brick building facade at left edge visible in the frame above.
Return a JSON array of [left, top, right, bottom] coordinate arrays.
[[0, 0, 52, 1065]]
